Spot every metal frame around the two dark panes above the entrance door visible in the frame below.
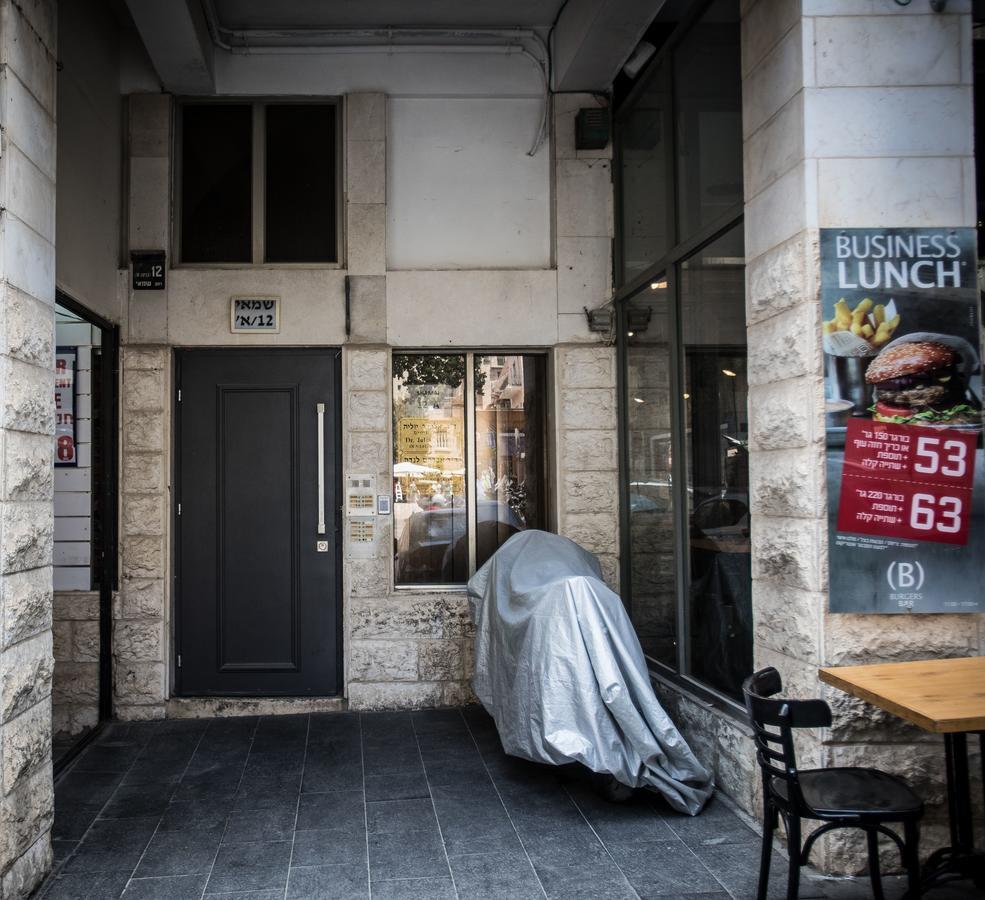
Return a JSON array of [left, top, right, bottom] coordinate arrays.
[[170, 96, 346, 269]]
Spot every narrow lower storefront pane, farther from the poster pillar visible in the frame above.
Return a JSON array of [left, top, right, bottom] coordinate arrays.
[[625, 277, 677, 668]]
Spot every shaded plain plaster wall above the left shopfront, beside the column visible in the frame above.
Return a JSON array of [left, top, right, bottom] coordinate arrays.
[[56, 0, 122, 322]]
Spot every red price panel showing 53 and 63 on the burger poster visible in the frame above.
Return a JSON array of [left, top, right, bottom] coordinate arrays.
[[838, 419, 978, 545]]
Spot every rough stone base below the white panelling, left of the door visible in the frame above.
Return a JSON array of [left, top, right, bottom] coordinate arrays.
[[51, 591, 99, 737]]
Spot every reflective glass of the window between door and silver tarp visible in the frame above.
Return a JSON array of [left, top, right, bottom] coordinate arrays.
[[393, 352, 547, 585]]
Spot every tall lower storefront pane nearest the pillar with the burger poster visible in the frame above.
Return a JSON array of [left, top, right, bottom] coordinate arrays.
[[681, 225, 753, 698]]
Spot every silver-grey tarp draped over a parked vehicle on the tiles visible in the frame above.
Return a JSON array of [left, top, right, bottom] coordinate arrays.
[[469, 531, 713, 815]]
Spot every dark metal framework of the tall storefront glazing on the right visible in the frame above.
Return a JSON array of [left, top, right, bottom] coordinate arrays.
[[613, 0, 744, 716]]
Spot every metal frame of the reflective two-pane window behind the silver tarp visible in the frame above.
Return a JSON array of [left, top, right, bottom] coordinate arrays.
[[389, 347, 553, 593]]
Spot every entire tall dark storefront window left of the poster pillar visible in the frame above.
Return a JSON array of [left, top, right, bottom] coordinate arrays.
[[615, 0, 753, 700]]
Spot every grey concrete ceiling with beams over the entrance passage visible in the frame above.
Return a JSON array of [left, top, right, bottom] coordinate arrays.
[[126, 0, 664, 95]]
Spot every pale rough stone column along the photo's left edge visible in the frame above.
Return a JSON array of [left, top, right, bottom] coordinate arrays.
[[0, 0, 55, 900]]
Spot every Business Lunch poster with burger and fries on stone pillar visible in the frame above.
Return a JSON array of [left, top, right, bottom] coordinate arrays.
[[821, 228, 985, 613]]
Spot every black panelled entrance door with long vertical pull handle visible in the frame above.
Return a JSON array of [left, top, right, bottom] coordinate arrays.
[[175, 349, 341, 696]]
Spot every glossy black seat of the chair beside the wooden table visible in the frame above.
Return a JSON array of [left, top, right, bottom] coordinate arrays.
[[771, 768, 923, 820]]
